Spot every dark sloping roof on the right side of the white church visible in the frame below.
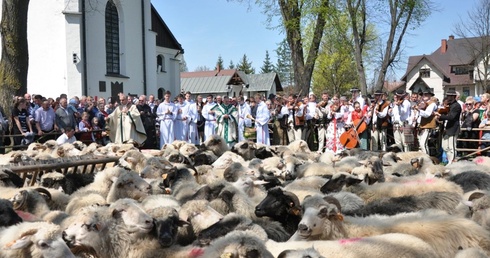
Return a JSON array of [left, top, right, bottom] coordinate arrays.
[[151, 5, 184, 54]]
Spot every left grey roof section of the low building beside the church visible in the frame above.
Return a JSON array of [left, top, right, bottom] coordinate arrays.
[[180, 75, 232, 94]]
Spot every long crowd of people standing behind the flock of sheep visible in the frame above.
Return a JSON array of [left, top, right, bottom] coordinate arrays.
[[0, 88, 490, 163]]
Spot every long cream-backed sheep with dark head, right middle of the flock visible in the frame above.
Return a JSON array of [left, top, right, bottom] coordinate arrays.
[[321, 176, 463, 203]]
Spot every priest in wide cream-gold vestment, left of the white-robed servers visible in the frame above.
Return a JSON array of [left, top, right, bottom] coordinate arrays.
[[106, 93, 146, 145]]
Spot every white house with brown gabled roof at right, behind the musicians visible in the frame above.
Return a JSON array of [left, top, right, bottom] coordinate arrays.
[[402, 36, 489, 100]]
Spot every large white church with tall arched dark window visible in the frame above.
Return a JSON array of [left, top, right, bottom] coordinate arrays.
[[0, 0, 184, 98]]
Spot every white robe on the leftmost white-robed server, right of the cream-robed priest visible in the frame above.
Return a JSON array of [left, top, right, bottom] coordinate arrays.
[[157, 101, 177, 149]]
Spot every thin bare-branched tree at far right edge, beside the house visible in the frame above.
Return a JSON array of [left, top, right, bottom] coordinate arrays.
[[454, 0, 490, 92]]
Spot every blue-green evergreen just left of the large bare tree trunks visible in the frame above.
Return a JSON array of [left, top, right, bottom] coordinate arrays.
[[275, 39, 294, 87]]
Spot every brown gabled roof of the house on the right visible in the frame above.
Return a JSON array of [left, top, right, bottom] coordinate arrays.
[[402, 37, 490, 85]]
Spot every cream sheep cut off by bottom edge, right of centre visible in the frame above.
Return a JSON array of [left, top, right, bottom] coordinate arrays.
[[265, 233, 437, 258]]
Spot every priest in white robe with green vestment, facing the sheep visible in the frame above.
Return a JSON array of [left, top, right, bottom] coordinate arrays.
[[213, 96, 238, 148]]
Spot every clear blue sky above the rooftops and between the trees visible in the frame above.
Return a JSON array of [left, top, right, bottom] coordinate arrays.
[[156, 0, 479, 80]]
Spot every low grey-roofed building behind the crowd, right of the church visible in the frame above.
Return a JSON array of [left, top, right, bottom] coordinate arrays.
[[180, 69, 282, 98]]
